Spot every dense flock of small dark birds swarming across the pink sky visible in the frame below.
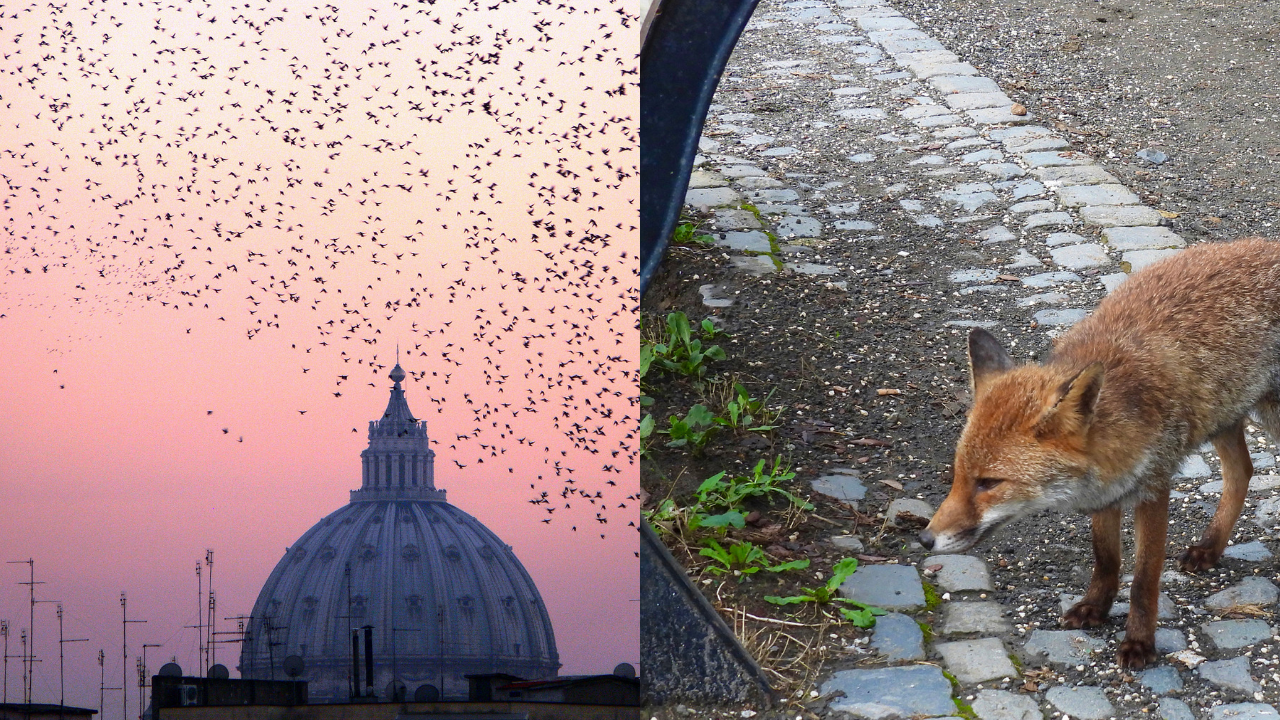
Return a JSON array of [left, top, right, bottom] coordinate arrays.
[[0, 0, 639, 536]]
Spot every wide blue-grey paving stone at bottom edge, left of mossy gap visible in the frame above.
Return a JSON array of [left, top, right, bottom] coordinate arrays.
[[818, 661, 956, 720]]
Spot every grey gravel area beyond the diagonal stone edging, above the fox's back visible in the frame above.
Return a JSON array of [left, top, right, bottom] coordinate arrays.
[[893, 0, 1280, 241]]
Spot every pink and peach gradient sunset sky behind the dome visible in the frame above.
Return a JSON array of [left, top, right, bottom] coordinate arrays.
[[0, 0, 639, 717]]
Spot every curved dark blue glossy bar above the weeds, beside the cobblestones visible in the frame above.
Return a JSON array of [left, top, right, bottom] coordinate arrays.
[[640, 0, 759, 297]]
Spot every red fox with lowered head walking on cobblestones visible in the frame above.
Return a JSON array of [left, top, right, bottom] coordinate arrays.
[[920, 238, 1280, 667]]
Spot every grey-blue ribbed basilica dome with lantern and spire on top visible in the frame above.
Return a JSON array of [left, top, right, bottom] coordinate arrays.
[[239, 364, 559, 702]]
